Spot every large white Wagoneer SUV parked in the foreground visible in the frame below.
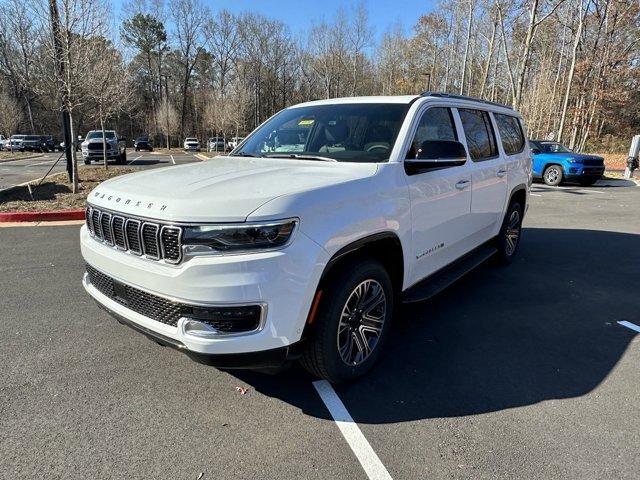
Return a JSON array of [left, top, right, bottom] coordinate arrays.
[[80, 94, 531, 382]]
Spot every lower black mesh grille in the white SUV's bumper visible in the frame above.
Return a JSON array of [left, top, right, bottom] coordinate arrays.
[[86, 264, 263, 334]]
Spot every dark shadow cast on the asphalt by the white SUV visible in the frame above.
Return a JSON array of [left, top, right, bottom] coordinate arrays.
[[231, 228, 640, 424]]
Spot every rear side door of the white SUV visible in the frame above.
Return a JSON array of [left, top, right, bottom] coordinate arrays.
[[458, 108, 508, 245]]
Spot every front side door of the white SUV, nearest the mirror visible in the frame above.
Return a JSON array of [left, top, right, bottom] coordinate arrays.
[[405, 106, 471, 284]]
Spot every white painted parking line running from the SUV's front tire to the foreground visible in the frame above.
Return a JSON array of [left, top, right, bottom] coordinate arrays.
[[313, 380, 391, 480]]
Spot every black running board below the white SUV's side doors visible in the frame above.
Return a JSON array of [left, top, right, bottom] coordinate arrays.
[[402, 244, 498, 303]]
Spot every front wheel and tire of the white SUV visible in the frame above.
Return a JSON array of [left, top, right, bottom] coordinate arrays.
[[300, 260, 394, 383]]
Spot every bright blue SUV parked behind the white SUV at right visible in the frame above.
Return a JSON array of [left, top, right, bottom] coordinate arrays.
[[529, 140, 605, 186]]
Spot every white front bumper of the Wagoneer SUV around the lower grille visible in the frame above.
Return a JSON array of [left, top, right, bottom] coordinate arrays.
[[80, 226, 328, 355]]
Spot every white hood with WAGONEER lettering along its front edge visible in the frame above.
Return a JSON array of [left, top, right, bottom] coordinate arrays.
[[87, 157, 378, 222]]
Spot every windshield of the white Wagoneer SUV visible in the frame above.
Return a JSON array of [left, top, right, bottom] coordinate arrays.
[[234, 103, 409, 162]]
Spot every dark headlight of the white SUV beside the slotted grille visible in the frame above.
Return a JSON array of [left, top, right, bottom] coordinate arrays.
[[182, 219, 298, 253]]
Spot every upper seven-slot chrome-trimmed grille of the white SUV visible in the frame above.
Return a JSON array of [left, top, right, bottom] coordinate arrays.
[[86, 205, 182, 263]]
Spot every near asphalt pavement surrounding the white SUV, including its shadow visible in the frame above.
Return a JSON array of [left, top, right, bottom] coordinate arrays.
[[0, 179, 640, 480]]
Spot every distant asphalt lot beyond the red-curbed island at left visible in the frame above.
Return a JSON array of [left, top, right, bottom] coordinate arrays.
[[0, 149, 200, 192]]
